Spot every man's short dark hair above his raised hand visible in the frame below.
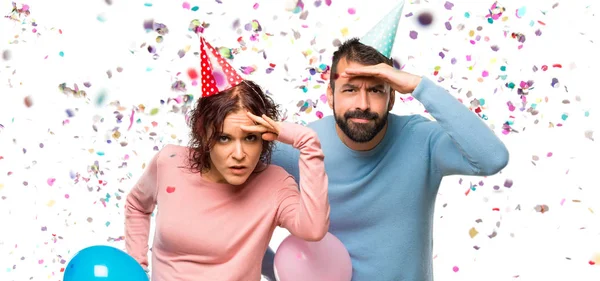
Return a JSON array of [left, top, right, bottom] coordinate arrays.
[[329, 38, 393, 90]]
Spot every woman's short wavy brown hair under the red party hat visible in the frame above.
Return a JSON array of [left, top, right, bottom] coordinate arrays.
[[188, 80, 279, 172]]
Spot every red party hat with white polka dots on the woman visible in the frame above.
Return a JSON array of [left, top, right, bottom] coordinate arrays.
[[200, 37, 243, 97]]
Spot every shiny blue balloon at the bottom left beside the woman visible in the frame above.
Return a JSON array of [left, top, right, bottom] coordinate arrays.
[[63, 246, 148, 281]]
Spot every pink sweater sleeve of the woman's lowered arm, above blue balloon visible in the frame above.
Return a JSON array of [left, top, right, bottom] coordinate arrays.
[[125, 152, 160, 269]]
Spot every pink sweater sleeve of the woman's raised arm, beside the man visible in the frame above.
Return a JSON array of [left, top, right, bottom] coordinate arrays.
[[276, 123, 330, 241]]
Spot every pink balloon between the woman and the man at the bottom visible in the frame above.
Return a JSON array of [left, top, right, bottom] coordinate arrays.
[[275, 233, 352, 281]]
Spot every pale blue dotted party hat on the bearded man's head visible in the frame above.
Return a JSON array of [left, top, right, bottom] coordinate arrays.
[[360, 0, 404, 58]]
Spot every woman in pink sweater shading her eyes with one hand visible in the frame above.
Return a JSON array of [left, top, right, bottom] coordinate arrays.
[[125, 81, 329, 281]]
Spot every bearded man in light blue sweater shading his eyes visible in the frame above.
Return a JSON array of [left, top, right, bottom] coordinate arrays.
[[263, 35, 509, 281]]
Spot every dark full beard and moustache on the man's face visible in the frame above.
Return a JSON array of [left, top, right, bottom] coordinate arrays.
[[333, 106, 388, 143]]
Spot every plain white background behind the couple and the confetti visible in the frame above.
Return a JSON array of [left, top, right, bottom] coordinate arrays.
[[0, 0, 600, 280]]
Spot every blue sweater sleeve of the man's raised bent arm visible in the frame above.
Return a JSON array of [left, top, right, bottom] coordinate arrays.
[[413, 74, 509, 176]]
